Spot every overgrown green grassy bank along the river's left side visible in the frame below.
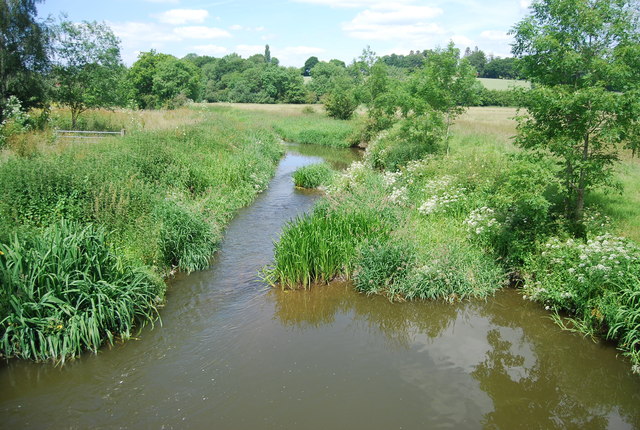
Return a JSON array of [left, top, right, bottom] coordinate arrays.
[[0, 107, 282, 360]]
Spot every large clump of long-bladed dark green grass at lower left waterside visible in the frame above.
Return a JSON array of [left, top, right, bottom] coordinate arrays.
[[0, 220, 164, 361]]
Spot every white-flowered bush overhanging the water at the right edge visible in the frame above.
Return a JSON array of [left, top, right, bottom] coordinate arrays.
[[524, 234, 640, 372]]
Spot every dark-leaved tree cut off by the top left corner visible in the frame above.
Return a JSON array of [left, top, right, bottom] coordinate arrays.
[[0, 0, 50, 122]]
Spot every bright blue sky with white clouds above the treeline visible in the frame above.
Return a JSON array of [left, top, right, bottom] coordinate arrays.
[[38, 0, 529, 67]]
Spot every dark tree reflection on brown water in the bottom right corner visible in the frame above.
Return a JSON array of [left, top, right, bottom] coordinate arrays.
[[472, 294, 640, 429]]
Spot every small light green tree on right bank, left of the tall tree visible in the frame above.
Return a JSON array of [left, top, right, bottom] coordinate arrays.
[[405, 42, 481, 149]]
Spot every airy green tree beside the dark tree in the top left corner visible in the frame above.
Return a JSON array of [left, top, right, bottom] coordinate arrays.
[[53, 21, 124, 127]]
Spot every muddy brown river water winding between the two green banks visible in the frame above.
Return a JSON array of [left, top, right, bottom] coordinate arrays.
[[0, 147, 640, 429]]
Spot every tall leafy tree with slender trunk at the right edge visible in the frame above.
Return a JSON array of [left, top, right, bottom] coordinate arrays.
[[512, 0, 640, 235]]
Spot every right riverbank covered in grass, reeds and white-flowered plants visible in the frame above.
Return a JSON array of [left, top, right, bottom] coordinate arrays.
[[267, 108, 640, 371]]
